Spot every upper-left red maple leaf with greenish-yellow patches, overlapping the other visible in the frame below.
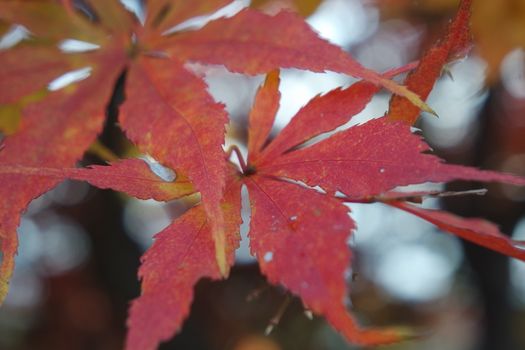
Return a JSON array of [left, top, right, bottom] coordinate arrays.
[[0, 0, 428, 301]]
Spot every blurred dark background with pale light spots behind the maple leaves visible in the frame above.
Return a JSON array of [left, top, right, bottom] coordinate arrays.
[[0, 0, 525, 350]]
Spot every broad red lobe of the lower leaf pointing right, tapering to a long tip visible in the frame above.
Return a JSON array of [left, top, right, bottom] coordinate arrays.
[[256, 118, 525, 199]]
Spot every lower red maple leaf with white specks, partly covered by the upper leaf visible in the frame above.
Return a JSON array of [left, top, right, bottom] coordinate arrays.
[[0, 65, 525, 349]]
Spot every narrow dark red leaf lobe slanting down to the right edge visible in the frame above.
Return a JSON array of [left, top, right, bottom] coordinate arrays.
[[388, 201, 525, 261]]
